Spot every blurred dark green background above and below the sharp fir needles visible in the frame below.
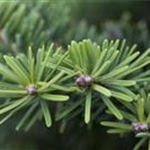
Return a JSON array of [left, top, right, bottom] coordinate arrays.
[[0, 0, 150, 150]]
